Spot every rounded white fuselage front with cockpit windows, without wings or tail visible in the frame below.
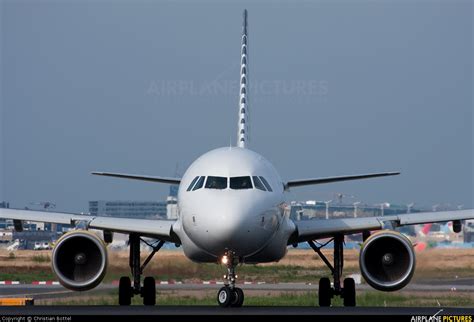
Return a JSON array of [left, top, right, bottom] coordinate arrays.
[[173, 147, 294, 263]]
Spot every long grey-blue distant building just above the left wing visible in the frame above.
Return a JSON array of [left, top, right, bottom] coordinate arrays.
[[89, 200, 167, 219]]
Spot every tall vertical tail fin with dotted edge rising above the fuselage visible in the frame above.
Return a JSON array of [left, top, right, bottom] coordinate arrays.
[[237, 9, 249, 148]]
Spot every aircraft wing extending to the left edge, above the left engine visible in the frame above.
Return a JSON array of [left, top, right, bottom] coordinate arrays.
[[0, 208, 181, 243]]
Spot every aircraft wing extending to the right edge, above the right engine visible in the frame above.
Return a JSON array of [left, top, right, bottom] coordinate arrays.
[[289, 209, 474, 244]]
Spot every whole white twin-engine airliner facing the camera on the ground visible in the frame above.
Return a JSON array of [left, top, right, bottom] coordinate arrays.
[[0, 10, 474, 307]]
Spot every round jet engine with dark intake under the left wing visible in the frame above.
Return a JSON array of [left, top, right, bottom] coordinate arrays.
[[52, 230, 107, 291]]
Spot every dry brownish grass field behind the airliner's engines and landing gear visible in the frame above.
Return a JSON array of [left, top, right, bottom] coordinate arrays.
[[0, 249, 474, 283]]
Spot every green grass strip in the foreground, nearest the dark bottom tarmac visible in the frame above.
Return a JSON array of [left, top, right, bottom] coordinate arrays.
[[37, 291, 474, 307]]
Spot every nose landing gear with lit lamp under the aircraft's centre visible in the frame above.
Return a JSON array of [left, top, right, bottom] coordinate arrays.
[[217, 252, 244, 307]]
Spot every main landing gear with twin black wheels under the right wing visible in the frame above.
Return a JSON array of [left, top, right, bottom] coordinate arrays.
[[308, 235, 356, 306]]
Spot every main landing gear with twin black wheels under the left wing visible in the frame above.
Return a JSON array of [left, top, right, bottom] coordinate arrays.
[[119, 234, 165, 305]]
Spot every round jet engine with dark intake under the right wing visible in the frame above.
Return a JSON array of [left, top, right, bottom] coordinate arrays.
[[359, 230, 415, 292]]
